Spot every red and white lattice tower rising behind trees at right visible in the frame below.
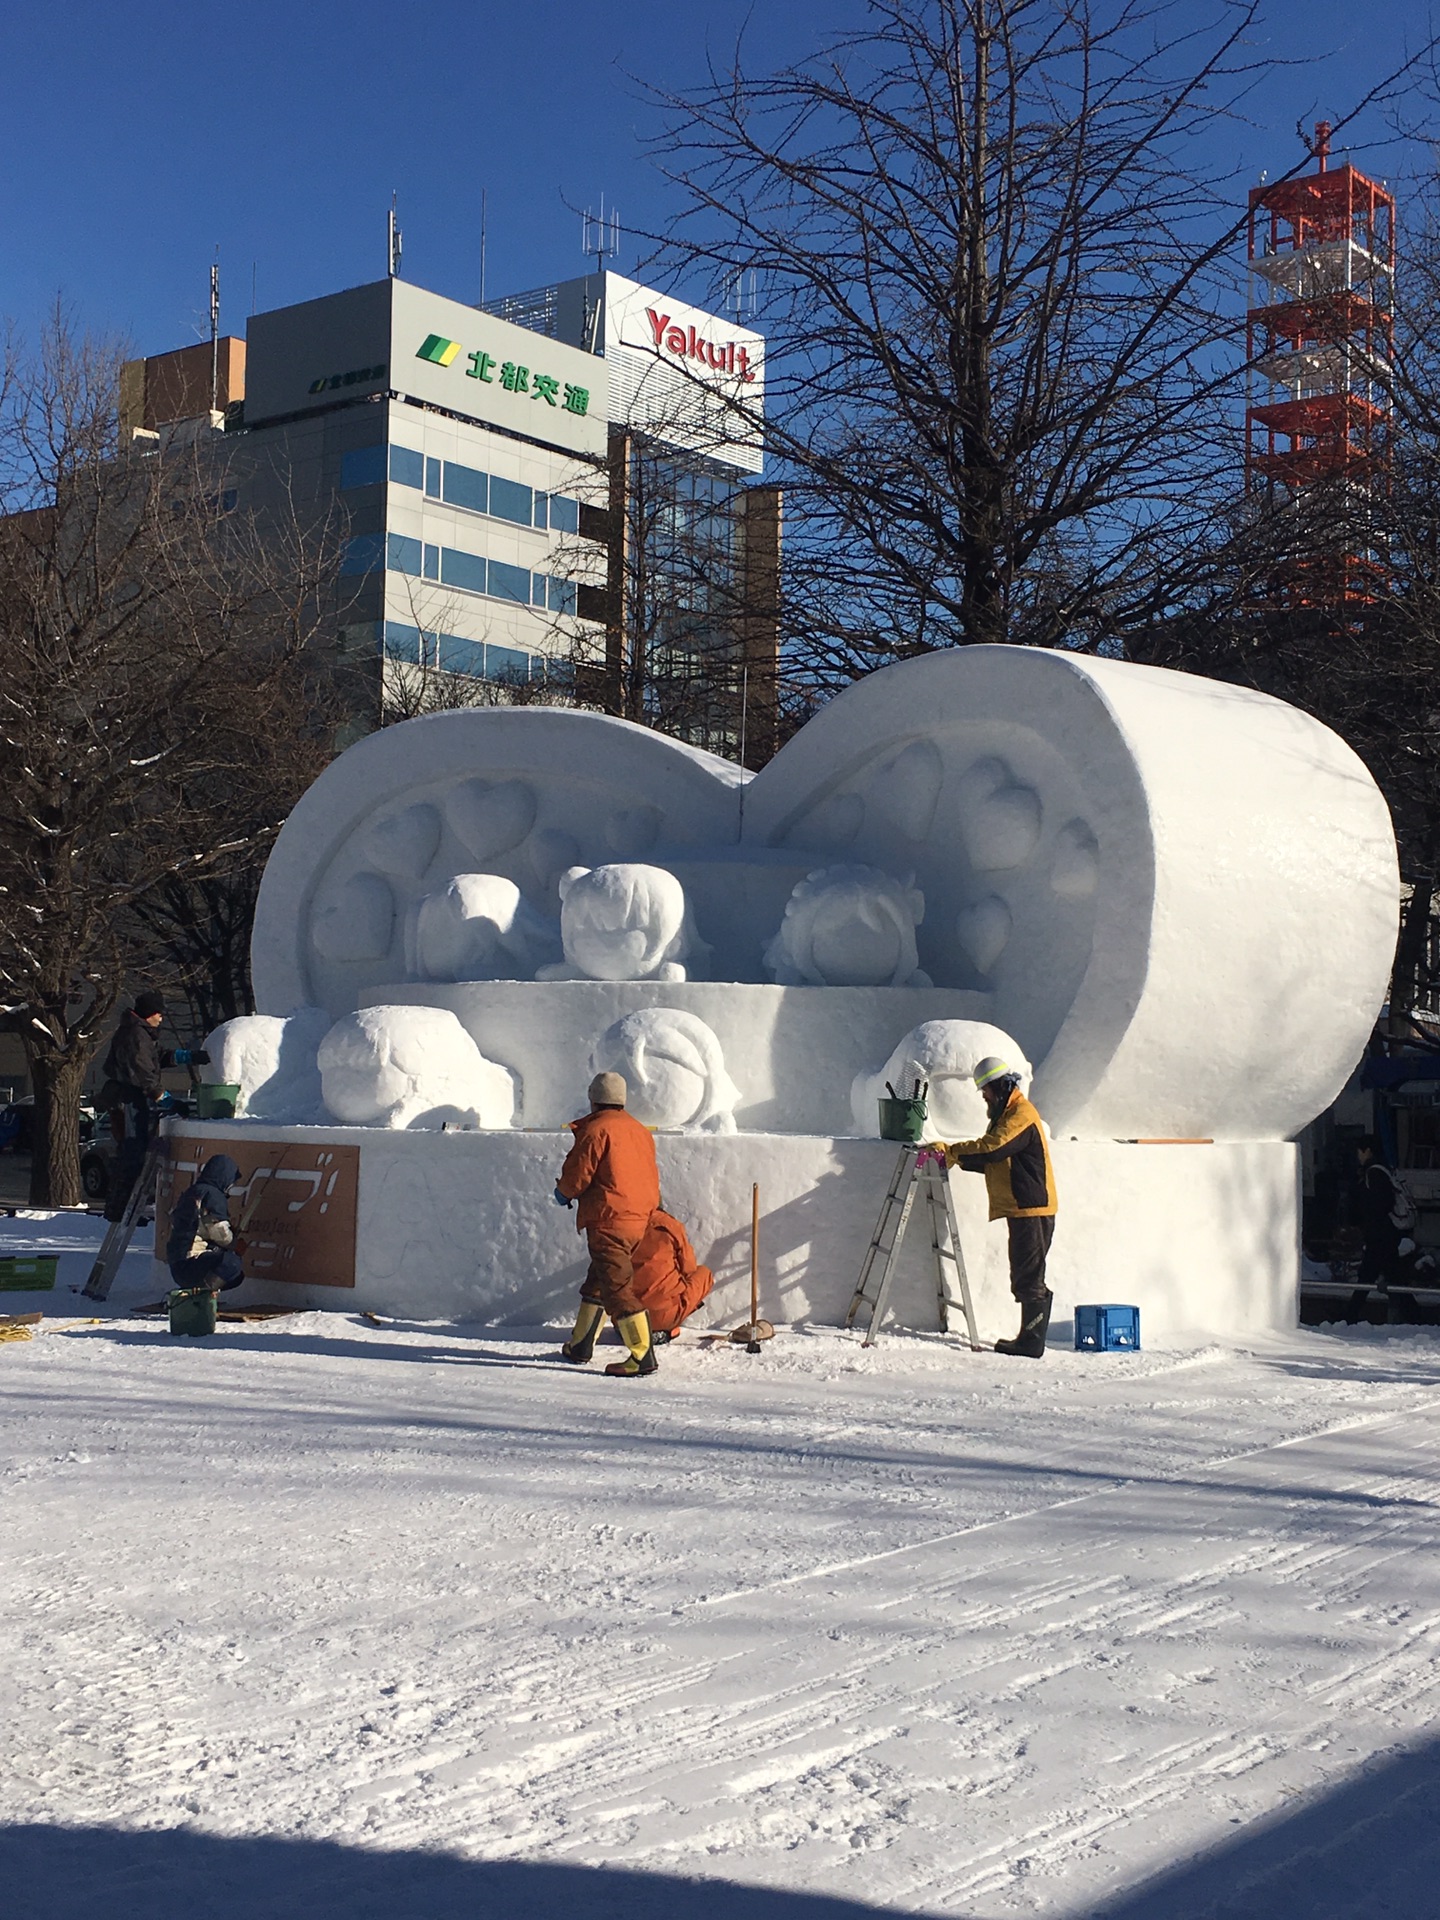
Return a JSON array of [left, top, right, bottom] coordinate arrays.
[[1246, 121, 1396, 616]]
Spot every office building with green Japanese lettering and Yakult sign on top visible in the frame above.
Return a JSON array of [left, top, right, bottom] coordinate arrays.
[[121, 273, 780, 751]]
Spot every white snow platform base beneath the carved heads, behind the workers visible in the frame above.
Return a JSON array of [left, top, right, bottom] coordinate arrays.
[[157, 1121, 1300, 1344]]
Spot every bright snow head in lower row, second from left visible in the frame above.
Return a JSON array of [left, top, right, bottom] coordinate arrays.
[[321, 1006, 518, 1131]]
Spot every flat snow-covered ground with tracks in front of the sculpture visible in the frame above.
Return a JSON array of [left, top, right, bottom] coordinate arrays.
[[0, 1219, 1440, 1920]]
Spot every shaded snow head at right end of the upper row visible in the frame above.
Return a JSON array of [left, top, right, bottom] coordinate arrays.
[[764, 866, 931, 987]]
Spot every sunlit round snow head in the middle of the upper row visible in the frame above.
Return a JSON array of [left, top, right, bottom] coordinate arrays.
[[538, 864, 707, 981]]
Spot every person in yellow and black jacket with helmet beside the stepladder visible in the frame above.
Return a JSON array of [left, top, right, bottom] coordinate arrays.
[[935, 1054, 1056, 1359]]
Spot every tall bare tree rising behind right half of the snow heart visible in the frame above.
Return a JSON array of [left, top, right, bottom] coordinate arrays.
[[657, 0, 1436, 685]]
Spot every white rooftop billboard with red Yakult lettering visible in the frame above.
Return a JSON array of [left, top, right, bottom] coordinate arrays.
[[605, 273, 764, 472]]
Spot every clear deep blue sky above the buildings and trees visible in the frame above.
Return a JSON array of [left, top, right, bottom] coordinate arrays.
[[0, 0, 1428, 353]]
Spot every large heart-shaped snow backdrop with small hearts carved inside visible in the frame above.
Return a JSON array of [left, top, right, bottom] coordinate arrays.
[[253, 647, 1398, 1140]]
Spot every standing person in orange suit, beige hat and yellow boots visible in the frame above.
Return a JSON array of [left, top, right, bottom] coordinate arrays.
[[555, 1073, 660, 1379]]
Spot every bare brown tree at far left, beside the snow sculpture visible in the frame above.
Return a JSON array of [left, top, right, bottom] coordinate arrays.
[[0, 313, 334, 1204]]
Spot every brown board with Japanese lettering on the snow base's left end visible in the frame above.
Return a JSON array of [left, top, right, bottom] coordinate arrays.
[[156, 1133, 359, 1286]]
